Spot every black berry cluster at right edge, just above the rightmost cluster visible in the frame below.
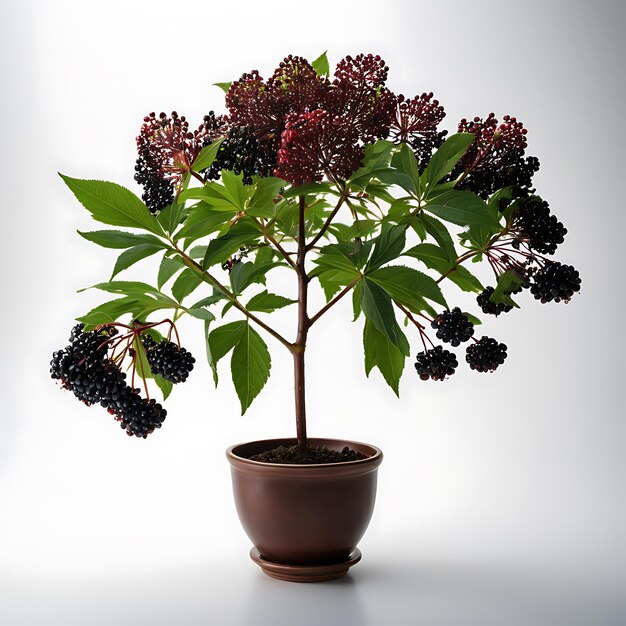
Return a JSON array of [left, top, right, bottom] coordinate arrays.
[[513, 196, 567, 254]]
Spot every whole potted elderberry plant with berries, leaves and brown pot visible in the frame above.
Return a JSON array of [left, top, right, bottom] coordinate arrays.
[[51, 54, 581, 581]]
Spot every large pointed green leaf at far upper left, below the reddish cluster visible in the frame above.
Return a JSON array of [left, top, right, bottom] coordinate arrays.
[[59, 174, 163, 235]]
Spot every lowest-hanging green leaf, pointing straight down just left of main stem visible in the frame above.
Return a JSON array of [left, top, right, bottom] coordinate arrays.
[[230, 322, 272, 415]]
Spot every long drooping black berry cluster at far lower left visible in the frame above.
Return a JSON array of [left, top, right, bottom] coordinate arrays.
[[50, 324, 167, 438]]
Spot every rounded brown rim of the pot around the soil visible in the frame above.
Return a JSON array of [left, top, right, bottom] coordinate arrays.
[[226, 437, 383, 474]]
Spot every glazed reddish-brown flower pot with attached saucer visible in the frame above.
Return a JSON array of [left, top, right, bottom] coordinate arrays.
[[226, 438, 383, 582]]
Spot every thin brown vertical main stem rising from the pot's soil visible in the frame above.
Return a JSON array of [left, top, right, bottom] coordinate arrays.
[[293, 196, 310, 456]]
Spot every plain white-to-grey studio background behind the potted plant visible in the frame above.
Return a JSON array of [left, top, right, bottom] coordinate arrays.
[[0, 0, 626, 626]]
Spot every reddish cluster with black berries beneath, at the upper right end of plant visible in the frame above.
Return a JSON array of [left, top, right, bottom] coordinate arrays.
[[452, 113, 539, 198]]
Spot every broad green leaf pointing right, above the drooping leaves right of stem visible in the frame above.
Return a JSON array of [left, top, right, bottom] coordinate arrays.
[[368, 265, 448, 311]]
